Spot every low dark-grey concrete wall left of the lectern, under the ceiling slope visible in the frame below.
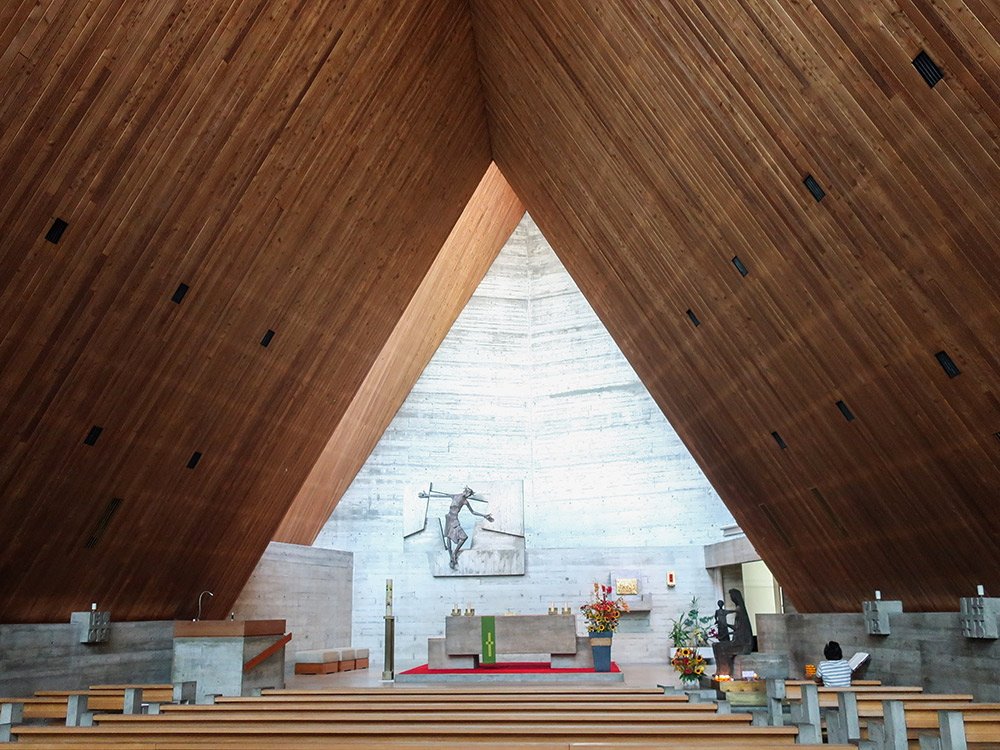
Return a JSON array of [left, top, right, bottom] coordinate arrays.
[[0, 621, 174, 697]]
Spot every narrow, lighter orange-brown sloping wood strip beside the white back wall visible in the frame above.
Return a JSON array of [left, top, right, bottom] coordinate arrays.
[[274, 165, 524, 545]]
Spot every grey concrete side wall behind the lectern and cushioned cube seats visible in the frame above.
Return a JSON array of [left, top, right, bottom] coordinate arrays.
[[234, 542, 354, 673]]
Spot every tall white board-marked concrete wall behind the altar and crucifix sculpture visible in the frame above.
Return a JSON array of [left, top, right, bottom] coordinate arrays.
[[316, 216, 733, 669]]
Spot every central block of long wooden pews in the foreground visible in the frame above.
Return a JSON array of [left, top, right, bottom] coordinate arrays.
[[1, 686, 836, 750]]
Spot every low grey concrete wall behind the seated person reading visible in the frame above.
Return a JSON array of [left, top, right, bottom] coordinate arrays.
[[757, 612, 1000, 702]]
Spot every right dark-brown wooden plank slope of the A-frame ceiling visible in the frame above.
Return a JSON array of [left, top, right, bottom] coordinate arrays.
[[471, 0, 1000, 611]]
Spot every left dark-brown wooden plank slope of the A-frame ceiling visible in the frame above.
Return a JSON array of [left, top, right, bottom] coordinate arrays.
[[0, 0, 490, 622]]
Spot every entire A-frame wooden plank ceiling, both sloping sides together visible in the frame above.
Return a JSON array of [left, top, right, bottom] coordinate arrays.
[[0, 0, 1000, 621]]
